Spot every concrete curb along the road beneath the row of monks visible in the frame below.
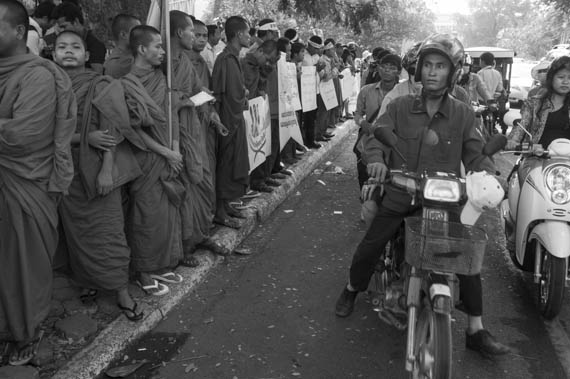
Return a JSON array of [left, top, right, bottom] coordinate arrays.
[[52, 121, 357, 379]]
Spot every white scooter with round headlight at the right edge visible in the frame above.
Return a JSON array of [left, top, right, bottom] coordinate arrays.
[[501, 129, 570, 319]]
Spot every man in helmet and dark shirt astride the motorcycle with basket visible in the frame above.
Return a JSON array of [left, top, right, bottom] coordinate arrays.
[[335, 34, 509, 355]]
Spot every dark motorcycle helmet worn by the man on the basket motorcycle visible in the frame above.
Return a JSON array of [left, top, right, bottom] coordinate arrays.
[[414, 34, 465, 89]]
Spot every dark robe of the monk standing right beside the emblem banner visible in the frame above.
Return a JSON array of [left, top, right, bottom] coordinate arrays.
[[212, 45, 249, 200]]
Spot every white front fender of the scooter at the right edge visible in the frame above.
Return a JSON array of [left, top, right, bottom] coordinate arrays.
[[529, 220, 570, 258]]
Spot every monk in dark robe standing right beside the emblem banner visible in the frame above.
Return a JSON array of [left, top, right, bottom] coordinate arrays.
[[212, 16, 250, 228]]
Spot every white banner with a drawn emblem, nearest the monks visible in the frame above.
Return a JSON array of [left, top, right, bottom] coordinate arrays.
[[243, 96, 271, 173]]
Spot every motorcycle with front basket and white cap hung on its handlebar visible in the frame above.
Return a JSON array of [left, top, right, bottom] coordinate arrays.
[[369, 128, 506, 379]]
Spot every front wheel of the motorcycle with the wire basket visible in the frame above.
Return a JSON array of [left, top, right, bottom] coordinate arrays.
[[411, 307, 452, 379]]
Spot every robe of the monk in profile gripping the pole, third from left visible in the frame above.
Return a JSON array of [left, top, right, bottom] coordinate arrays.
[[121, 67, 185, 272]]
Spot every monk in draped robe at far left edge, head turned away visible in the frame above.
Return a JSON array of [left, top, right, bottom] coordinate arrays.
[[0, 0, 77, 365]]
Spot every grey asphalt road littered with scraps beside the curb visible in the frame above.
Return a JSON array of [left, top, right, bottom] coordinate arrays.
[[102, 131, 570, 379]]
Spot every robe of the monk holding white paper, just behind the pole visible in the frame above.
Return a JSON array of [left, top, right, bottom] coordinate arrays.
[[172, 51, 215, 252]]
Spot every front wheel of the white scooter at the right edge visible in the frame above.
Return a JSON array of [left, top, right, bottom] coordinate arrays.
[[536, 246, 568, 320]]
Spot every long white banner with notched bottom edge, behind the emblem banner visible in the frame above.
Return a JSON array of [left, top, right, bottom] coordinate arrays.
[[277, 59, 303, 150]]
